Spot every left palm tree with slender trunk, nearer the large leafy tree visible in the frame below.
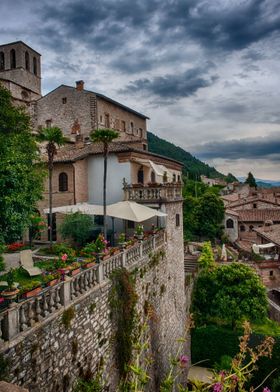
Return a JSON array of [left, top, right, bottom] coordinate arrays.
[[37, 127, 67, 247]]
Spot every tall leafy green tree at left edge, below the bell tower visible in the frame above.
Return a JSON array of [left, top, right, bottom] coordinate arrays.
[[0, 86, 44, 243]]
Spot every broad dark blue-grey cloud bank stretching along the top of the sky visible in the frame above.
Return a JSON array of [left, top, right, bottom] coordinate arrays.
[[34, 0, 280, 62]]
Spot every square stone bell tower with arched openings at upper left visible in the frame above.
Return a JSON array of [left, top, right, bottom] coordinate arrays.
[[0, 41, 41, 106]]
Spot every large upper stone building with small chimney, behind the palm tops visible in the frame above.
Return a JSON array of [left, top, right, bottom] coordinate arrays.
[[35, 80, 148, 150]]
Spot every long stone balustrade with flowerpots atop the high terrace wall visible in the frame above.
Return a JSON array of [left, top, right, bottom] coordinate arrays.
[[0, 231, 165, 345]]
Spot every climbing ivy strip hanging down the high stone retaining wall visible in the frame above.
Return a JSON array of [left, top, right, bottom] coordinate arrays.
[[110, 268, 138, 379]]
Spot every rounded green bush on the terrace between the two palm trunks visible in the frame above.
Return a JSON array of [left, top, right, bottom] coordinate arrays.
[[59, 212, 94, 246]]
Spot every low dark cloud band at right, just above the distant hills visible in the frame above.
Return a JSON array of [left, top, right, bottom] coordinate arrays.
[[194, 132, 280, 162]]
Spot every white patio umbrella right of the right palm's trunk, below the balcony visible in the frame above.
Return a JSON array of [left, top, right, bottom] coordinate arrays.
[[107, 201, 167, 222]]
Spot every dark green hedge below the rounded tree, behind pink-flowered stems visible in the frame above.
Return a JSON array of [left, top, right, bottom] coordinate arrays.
[[191, 325, 280, 392]]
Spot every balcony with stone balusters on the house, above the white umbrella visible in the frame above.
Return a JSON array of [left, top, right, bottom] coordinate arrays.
[[123, 182, 183, 203]]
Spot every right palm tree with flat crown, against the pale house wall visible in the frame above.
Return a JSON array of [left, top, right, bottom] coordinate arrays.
[[90, 128, 119, 239]]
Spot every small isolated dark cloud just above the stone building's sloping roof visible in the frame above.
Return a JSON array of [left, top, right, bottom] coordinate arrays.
[[121, 68, 217, 102]]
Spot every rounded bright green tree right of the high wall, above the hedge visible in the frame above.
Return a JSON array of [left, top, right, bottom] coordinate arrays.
[[192, 263, 268, 327]]
